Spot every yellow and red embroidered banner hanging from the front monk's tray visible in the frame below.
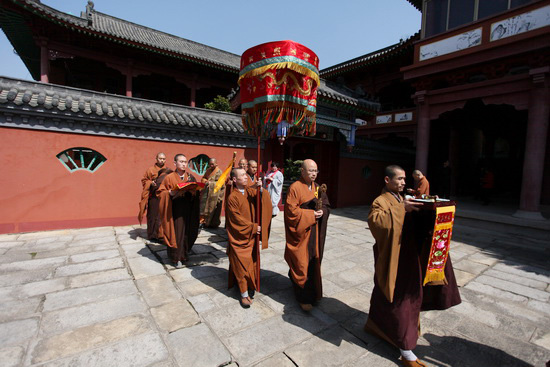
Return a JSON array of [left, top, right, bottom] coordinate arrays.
[[422, 205, 455, 285]]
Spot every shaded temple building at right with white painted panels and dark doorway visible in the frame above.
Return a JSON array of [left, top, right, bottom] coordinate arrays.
[[321, 0, 550, 219]]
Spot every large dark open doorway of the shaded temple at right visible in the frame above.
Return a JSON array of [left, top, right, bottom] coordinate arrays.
[[428, 99, 527, 205]]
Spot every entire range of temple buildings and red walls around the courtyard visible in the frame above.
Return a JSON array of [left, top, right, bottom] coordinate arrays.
[[0, 0, 550, 233]]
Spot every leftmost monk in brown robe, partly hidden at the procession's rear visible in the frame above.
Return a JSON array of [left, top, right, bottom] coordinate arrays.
[[138, 153, 166, 242]]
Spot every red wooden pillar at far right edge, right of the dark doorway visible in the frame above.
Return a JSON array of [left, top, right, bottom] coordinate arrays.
[[514, 66, 550, 219]]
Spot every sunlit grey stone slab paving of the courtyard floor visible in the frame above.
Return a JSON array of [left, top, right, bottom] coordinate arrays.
[[0, 207, 550, 367]]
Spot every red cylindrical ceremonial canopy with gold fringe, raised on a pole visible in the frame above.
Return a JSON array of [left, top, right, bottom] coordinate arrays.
[[239, 41, 319, 138]]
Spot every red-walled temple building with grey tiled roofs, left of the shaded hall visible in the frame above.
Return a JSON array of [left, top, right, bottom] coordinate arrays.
[[0, 0, 406, 233]]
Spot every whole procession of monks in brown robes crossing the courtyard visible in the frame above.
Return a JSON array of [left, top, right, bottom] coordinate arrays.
[[138, 153, 461, 366]]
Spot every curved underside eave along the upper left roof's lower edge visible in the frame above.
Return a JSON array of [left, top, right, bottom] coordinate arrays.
[[12, 0, 239, 74]]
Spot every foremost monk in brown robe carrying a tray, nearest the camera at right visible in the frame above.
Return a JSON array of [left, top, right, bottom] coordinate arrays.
[[365, 165, 460, 367]]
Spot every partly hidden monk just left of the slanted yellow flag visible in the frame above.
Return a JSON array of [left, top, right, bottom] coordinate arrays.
[[200, 158, 225, 228]]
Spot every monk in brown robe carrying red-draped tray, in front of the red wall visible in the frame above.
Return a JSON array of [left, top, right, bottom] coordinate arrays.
[[157, 154, 200, 268]]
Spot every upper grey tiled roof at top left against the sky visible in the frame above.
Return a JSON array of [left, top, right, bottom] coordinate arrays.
[[12, 0, 240, 71]]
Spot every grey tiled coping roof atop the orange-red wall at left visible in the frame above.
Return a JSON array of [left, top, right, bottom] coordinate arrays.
[[0, 76, 244, 136]]
